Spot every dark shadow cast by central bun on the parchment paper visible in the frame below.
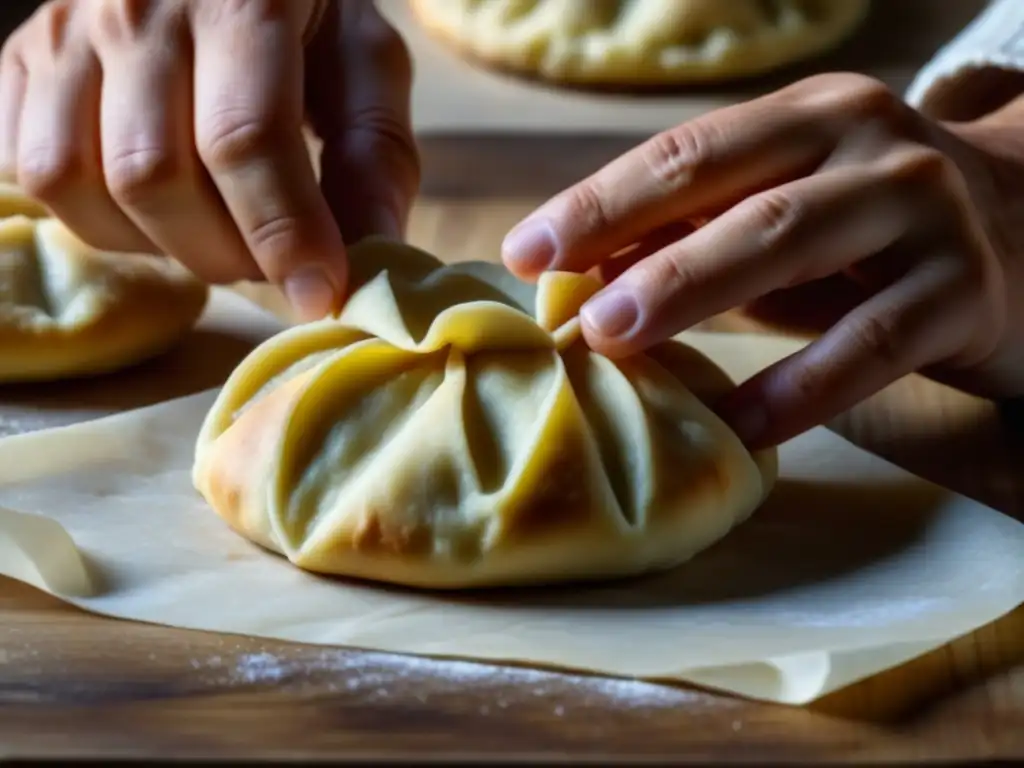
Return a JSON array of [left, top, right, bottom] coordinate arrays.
[[358, 480, 945, 621]]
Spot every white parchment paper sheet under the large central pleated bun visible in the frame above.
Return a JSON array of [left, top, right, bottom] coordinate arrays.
[[0, 292, 1024, 703]]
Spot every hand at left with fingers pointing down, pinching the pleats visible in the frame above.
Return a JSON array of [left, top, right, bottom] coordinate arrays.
[[0, 0, 419, 318]]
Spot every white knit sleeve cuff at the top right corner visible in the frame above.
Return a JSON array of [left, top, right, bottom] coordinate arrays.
[[906, 0, 1024, 120]]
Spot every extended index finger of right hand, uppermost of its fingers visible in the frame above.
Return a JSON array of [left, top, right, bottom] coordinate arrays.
[[502, 75, 897, 278]]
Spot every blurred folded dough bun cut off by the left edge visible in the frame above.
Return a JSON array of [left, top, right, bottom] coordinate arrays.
[[0, 185, 208, 383]]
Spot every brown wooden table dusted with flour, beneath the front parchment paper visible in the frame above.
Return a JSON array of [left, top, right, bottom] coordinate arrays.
[[0, 199, 1024, 763]]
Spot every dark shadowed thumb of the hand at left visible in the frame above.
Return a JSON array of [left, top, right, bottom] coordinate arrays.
[[306, 0, 420, 243]]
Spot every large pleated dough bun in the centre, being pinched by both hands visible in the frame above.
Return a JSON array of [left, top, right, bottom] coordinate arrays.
[[193, 240, 775, 589]]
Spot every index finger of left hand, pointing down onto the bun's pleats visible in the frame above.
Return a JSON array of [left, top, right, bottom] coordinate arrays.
[[194, 3, 347, 319]]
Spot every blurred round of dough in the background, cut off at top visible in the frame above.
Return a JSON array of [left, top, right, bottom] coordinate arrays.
[[412, 0, 869, 86]]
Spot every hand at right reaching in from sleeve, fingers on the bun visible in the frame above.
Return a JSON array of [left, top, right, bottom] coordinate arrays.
[[503, 75, 1024, 447]]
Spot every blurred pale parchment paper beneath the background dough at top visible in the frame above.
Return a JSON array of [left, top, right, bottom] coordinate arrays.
[[387, 0, 986, 136]]
